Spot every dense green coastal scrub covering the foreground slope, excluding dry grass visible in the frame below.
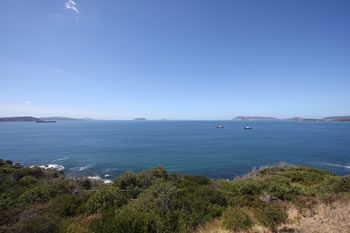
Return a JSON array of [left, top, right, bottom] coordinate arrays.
[[0, 160, 350, 233]]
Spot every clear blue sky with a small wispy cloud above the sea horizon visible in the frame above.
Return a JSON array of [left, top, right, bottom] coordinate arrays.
[[0, 0, 350, 120]]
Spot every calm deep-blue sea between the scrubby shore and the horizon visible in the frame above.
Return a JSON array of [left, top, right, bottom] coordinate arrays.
[[0, 121, 350, 178]]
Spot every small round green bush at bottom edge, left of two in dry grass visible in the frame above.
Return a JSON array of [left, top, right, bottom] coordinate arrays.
[[222, 208, 253, 231]]
